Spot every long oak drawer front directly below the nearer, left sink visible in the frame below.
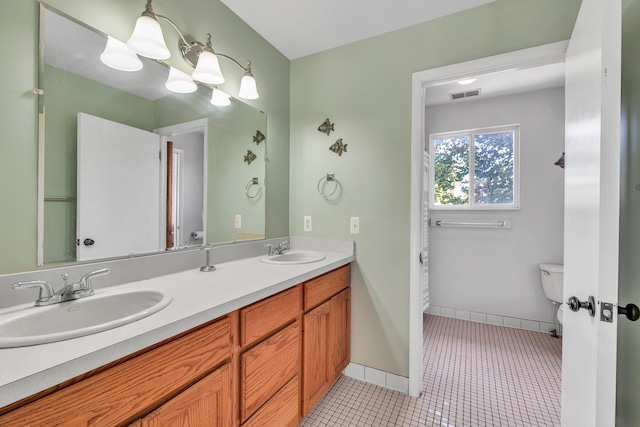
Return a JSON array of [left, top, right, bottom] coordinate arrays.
[[0, 317, 231, 427]]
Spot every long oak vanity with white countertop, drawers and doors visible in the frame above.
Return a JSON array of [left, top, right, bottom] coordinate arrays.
[[0, 241, 353, 426]]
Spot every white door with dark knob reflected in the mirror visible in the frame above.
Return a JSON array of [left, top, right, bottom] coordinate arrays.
[[76, 113, 161, 261]]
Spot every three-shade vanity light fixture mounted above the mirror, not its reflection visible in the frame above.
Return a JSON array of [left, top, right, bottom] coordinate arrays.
[[127, 0, 258, 99]]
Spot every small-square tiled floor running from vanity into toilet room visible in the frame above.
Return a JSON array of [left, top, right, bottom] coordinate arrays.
[[299, 315, 562, 427]]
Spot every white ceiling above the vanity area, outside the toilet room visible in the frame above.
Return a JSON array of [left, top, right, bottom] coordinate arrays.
[[222, 0, 495, 59]]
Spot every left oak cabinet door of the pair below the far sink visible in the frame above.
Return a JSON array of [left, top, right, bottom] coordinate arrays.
[[302, 300, 331, 415]]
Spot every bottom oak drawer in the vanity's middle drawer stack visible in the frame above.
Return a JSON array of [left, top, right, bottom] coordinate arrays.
[[242, 375, 300, 427]]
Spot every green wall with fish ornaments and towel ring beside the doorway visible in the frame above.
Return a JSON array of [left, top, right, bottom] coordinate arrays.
[[290, 0, 580, 376]]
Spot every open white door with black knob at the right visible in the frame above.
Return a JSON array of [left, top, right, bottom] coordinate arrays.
[[562, 0, 626, 427]]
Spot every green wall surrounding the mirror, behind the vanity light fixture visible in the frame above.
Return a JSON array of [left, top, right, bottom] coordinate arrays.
[[0, 0, 289, 274]]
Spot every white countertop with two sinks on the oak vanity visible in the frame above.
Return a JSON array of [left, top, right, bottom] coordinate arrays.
[[0, 242, 355, 408]]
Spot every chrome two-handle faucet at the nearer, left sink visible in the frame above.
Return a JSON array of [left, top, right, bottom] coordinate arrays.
[[11, 268, 111, 306]]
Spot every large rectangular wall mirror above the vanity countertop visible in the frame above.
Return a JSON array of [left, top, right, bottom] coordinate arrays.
[[36, 3, 266, 273]]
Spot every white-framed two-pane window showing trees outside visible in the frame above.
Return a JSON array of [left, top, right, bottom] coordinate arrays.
[[429, 125, 520, 209]]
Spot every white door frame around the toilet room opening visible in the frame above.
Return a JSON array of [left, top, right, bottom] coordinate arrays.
[[409, 40, 569, 396]]
